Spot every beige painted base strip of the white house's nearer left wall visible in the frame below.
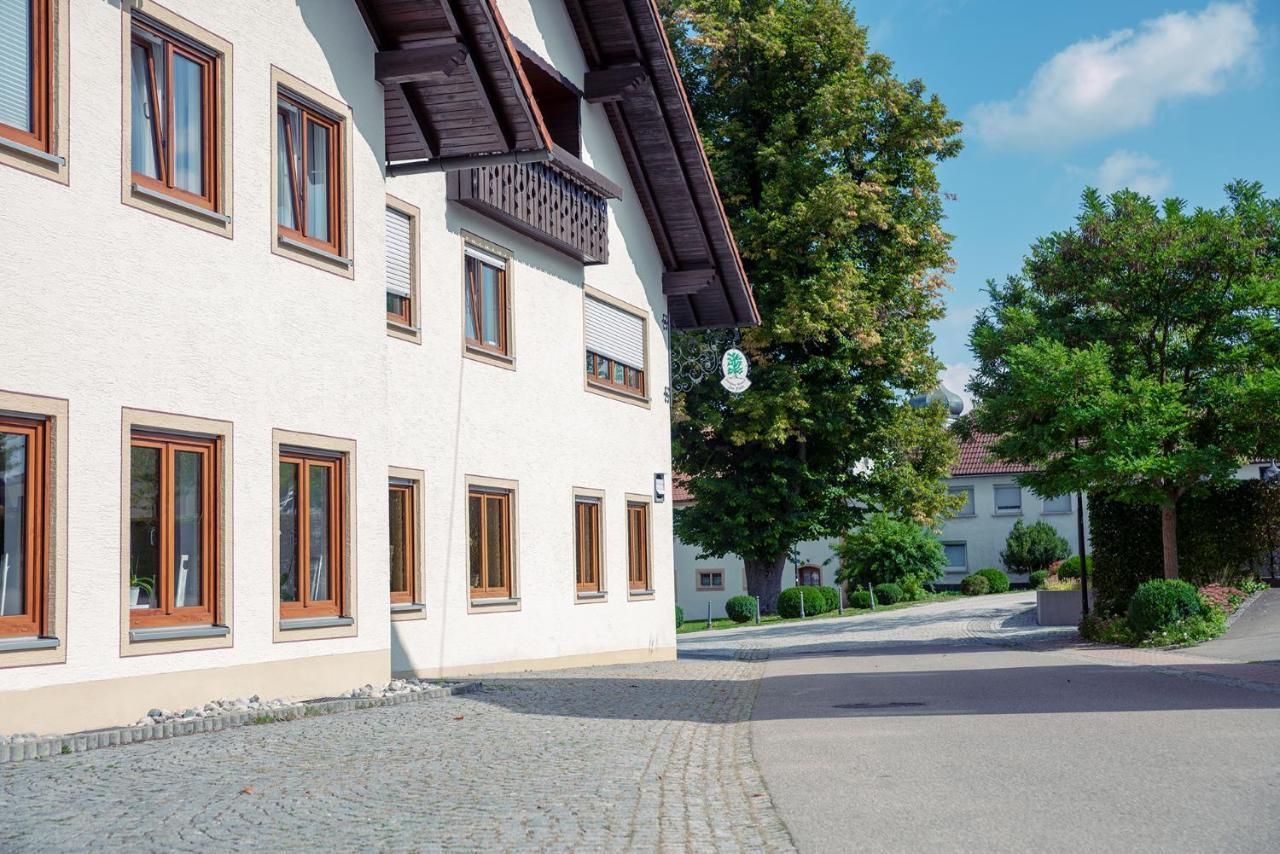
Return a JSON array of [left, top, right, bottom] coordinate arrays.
[[0, 649, 390, 735]]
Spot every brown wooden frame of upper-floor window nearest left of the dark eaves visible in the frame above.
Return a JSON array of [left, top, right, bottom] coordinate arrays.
[[271, 87, 347, 256]]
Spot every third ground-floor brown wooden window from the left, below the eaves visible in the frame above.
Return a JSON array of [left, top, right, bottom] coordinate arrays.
[[279, 451, 347, 618]]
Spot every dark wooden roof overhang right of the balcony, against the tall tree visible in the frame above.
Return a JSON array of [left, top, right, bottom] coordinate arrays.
[[564, 0, 760, 329]]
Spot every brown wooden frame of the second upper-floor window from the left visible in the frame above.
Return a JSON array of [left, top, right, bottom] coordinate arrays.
[[128, 14, 221, 211]]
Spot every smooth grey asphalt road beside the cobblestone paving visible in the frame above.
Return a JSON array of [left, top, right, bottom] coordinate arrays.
[[751, 597, 1280, 854]]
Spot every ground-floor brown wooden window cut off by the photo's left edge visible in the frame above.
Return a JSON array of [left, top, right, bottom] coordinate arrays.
[[0, 416, 49, 638]]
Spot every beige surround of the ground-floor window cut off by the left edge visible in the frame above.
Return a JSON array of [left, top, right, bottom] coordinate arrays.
[[0, 391, 69, 670]]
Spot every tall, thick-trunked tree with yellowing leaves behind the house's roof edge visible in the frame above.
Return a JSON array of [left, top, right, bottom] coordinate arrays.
[[663, 0, 960, 611]]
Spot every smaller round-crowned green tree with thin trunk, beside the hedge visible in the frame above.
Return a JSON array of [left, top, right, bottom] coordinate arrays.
[[969, 182, 1280, 579]]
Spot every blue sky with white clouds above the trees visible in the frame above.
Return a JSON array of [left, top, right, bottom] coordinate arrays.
[[852, 0, 1280, 409]]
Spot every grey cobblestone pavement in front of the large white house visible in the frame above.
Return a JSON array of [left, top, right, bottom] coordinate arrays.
[[0, 658, 792, 851]]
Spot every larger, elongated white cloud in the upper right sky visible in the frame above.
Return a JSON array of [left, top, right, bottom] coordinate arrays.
[[974, 0, 1260, 149]]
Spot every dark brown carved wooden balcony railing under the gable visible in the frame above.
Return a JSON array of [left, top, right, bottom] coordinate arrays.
[[449, 146, 621, 264]]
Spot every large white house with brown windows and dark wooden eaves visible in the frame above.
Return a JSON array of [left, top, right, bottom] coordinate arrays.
[[0, 0, 758, 732]]
